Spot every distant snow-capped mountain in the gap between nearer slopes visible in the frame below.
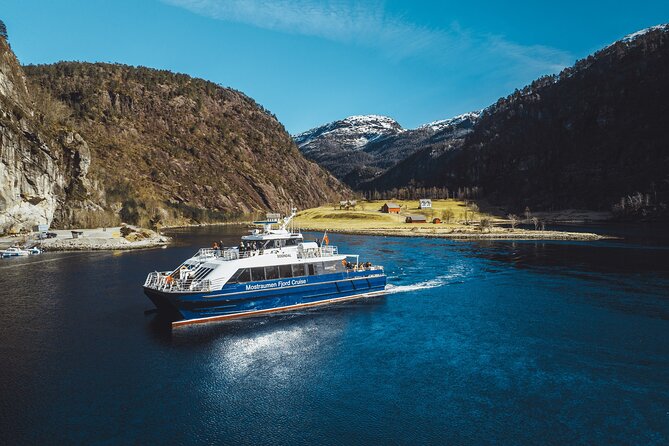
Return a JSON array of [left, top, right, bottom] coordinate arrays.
[[293, 113, 478, 187]]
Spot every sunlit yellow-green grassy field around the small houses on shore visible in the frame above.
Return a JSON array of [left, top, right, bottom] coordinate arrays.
[[295, 200, 493, 231]]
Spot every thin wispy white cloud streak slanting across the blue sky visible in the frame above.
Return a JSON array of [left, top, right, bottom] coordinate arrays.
[[163, 0, 573, 77]]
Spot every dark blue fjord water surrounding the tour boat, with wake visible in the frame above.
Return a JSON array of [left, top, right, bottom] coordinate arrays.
[[0, 228, 669, 445]]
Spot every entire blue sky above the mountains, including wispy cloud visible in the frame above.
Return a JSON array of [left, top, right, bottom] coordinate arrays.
[[0, 0, 669, 133]]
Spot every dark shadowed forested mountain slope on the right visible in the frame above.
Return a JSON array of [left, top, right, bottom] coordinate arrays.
[[364, 25, 669, 215]]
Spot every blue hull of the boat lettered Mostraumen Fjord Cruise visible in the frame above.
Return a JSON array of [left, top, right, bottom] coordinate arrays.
[[144, 271, 386, 326]]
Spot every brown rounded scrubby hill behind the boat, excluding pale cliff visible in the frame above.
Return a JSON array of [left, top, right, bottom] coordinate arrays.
[[24, 62, 346, 224]]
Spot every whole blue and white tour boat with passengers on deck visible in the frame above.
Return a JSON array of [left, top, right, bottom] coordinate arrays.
[[144, 209, 386, 327]]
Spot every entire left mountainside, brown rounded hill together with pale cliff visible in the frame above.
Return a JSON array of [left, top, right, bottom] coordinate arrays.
[[0, 37, 347, 232]]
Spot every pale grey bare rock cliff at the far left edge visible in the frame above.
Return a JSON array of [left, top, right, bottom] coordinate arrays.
[[0, 37, 96, 233]]
